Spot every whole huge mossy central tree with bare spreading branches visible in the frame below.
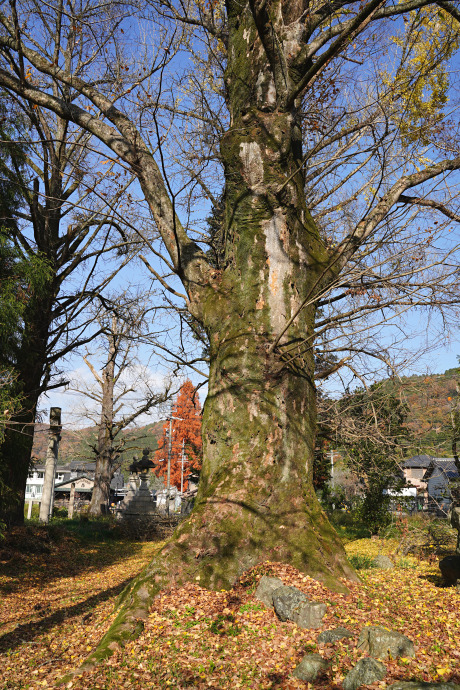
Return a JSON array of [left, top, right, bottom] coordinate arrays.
[[0, 0, 460, 643]]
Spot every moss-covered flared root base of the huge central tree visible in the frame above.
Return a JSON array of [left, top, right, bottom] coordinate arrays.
[[54, 492, 359, 684]]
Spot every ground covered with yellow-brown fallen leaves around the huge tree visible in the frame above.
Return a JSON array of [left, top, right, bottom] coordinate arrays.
[[0, 538, 460, 690]]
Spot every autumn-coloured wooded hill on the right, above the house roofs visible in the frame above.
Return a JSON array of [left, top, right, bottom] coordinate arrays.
[[388, 369, 460, 457]]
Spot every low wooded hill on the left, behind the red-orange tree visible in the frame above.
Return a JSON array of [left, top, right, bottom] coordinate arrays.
[[32, 422, 163, 465]]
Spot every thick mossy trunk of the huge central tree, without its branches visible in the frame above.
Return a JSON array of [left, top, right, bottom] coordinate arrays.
[[84, 4, 356, 658]]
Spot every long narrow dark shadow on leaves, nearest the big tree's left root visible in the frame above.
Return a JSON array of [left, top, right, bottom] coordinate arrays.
[[0, 577, 132, 653]]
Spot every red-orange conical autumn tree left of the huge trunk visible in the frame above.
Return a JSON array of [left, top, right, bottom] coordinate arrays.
[[155, 379, 202, 489]]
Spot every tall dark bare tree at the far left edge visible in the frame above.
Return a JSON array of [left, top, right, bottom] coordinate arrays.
[[0, 82, 139, 522]]
